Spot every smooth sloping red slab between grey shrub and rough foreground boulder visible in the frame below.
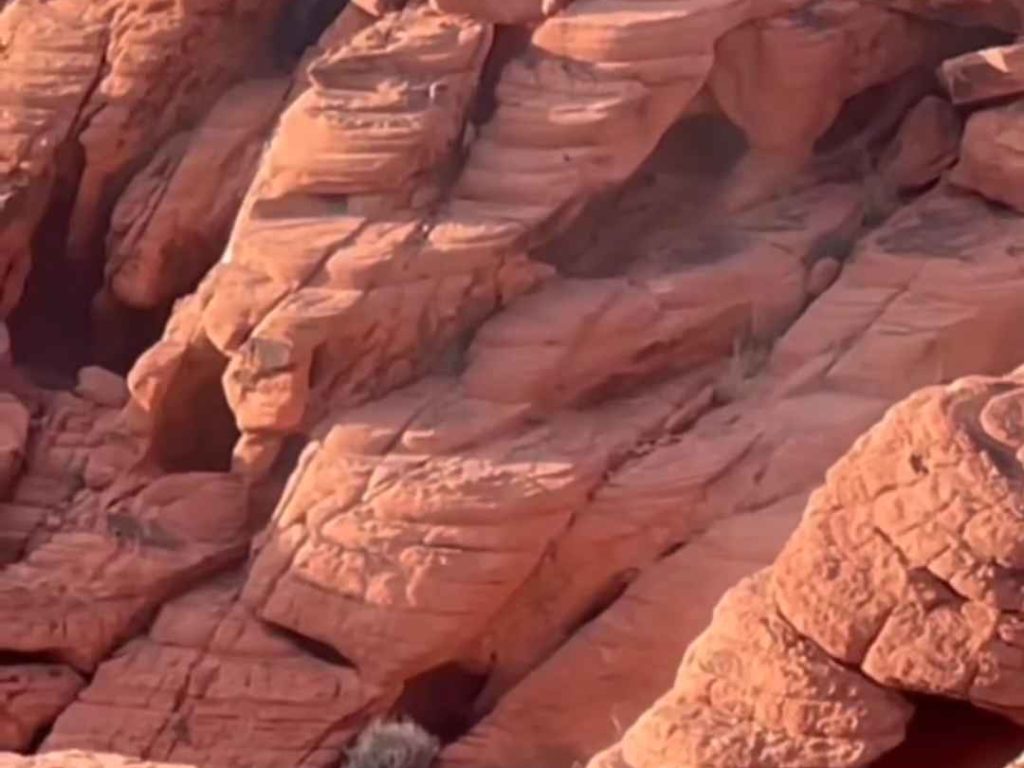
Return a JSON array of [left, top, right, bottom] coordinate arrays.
[[440, 500, 800, 768]]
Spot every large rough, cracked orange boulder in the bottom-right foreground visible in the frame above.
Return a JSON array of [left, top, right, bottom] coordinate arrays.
[[593, 370, 1024, 766]]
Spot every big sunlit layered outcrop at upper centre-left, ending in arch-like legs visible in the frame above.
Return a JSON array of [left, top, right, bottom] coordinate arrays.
[[135, 0, 806, 481]]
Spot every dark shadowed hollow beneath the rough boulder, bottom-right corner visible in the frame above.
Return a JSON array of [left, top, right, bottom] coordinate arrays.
[[871, 697, 1024, 768]]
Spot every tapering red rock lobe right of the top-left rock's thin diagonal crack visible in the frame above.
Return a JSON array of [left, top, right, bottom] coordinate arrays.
[[61, 0, 280, 268]]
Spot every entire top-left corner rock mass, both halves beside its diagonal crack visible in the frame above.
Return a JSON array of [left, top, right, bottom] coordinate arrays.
[[0, 0, 284, 314]]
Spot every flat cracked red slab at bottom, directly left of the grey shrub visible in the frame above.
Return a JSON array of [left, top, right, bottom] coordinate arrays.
[[41, 577, 398, 768]]
